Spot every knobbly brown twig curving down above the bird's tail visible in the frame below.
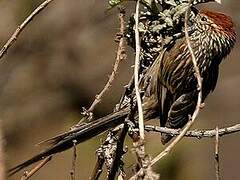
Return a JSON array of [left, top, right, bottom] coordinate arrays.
[[87, 8, 126, 113]]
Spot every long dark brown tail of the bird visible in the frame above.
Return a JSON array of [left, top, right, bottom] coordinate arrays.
[[8, 109, 129, 176]]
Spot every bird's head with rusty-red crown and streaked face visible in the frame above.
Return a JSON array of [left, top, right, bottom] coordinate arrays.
[[192, 10, 236, 57]]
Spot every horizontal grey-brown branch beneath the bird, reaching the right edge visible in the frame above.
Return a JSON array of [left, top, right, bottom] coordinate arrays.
[[145, 124, 240, 139]]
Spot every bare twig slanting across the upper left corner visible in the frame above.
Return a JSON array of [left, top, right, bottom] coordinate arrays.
[[0, 0, 53, 59]]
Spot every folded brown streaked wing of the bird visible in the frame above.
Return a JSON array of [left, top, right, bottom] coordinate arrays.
[[154, 38, 197, 144]]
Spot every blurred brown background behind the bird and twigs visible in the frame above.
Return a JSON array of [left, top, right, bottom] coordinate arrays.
[[0, 0, 240, 180]]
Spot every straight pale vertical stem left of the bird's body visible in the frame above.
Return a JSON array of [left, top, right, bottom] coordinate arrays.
[[134, 0, 144, 140]]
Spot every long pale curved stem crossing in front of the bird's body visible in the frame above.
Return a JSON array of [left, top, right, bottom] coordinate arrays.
[[130, 0, 202, 179]]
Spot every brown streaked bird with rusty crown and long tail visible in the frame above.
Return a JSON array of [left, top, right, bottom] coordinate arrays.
[[8, 4, 236, 175]]
